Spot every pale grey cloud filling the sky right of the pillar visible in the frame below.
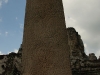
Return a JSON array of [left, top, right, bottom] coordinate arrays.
[[63, 0, 100, 55]]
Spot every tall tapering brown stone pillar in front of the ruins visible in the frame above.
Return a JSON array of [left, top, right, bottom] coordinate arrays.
[[22, 0, 71, 75]]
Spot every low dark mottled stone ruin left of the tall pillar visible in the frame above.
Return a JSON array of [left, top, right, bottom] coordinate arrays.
[[0, 45, 22, 75]]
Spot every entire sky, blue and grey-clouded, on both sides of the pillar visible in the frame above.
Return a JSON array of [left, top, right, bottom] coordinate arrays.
[[0, 0, 100, 57]]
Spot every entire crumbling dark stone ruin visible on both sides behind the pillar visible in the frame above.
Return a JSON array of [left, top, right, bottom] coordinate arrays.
[[0, 27, 100, 75]]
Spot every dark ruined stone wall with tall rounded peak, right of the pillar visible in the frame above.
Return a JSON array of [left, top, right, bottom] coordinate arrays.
[[67, 27, 100, 75]]
